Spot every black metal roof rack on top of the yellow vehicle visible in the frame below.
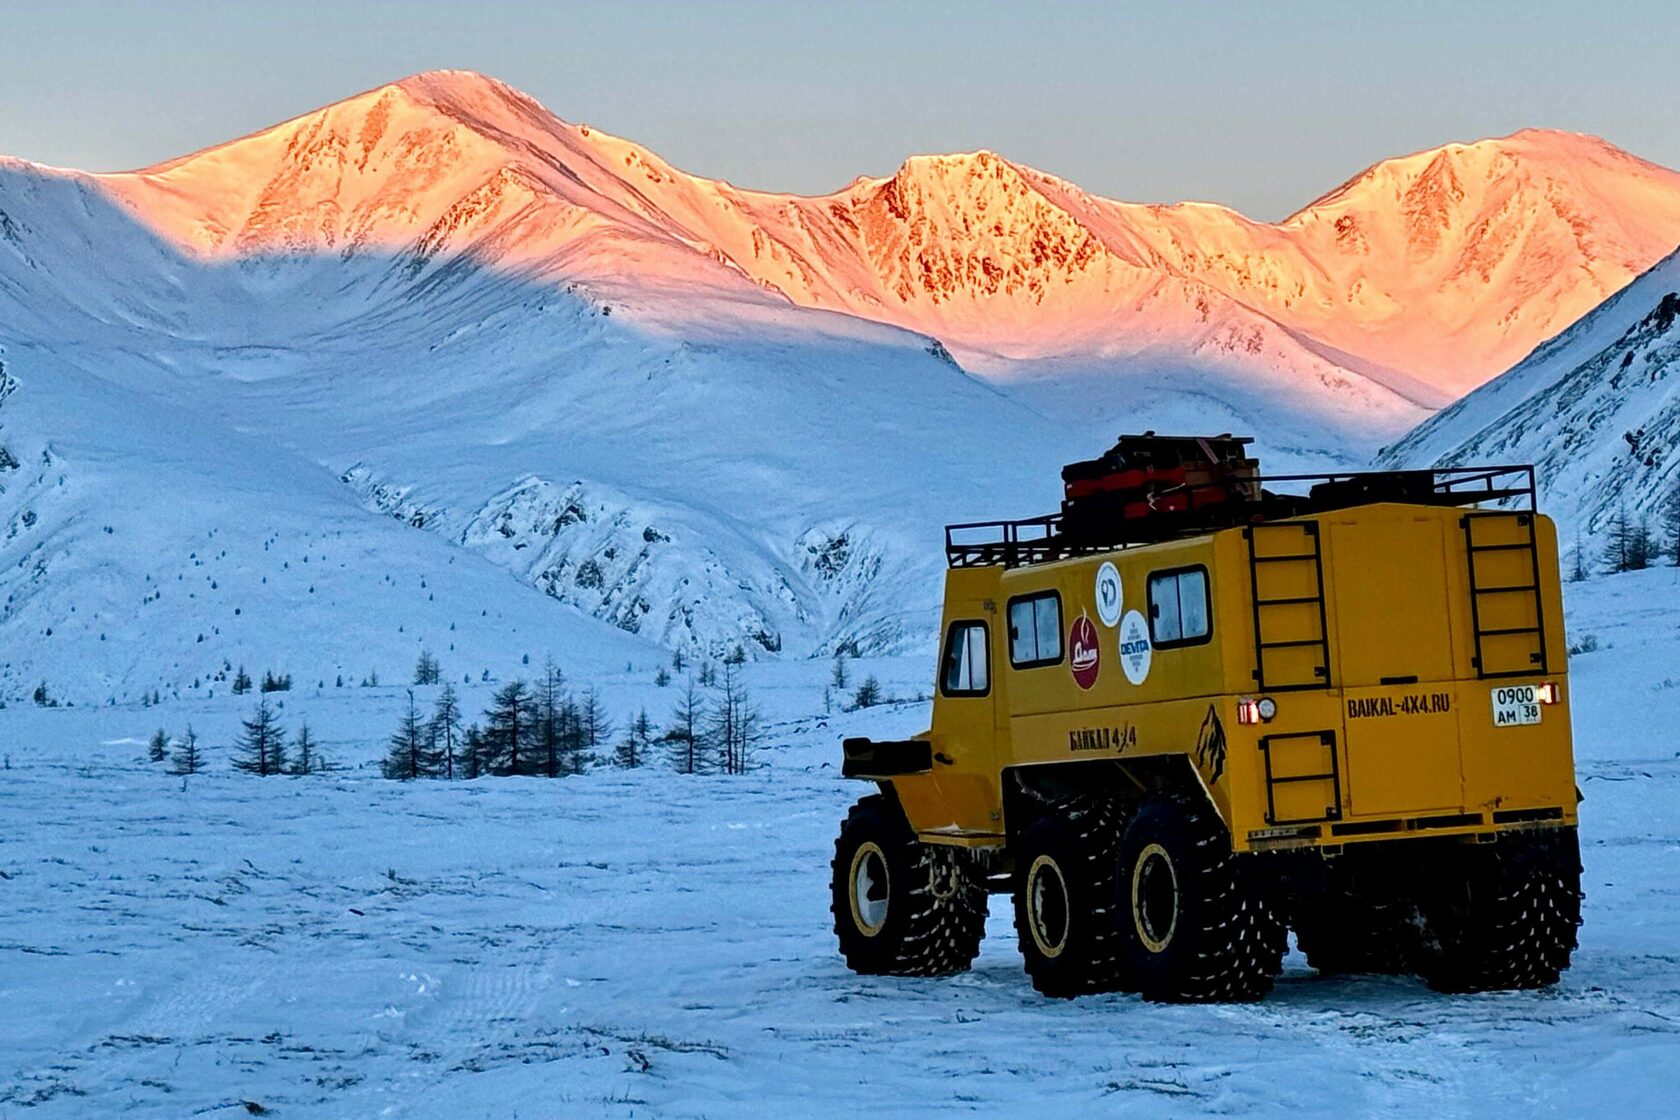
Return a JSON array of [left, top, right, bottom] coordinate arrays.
[[946, 463, 1534, 568]]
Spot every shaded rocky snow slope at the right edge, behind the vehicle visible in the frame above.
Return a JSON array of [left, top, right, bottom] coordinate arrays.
[[1379, 252, 1680, 557]]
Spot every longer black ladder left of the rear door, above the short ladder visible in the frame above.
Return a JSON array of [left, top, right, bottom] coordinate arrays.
[[1243, 521, 1331, 692]]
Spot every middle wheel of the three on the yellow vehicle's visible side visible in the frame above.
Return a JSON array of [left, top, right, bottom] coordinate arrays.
[[1015, 794, 1124, 999]]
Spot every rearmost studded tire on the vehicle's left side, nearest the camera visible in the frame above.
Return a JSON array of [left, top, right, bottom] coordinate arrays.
[[1119, 794, 1289, 1002]]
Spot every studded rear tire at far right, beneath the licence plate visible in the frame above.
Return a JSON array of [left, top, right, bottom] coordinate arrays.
[[1418, 828, 1581, 992]]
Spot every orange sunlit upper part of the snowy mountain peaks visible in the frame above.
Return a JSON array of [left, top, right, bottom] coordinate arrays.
[[55, 71, 1680, 397]]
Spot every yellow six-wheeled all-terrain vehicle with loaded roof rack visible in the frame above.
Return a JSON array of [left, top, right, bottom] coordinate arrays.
[[833, 433, 1581, 1001]]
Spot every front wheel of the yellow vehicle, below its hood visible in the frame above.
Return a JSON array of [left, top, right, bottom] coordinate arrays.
[[830, 794, 986, 976]]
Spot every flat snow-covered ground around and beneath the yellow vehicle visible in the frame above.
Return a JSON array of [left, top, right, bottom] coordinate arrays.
[[0, 569, 1680, 1120]]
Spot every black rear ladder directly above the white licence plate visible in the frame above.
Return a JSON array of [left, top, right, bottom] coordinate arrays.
[[1458, 510, 1547, 680]]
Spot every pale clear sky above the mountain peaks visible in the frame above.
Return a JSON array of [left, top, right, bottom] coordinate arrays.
[[0, 0, 1680, 218]]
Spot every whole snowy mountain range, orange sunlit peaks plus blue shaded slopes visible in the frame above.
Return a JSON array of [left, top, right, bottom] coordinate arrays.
[[0, 72, 1680, 699]]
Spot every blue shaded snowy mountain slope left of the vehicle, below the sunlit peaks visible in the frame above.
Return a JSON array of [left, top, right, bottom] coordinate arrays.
[[0, 143, 1067, 702]]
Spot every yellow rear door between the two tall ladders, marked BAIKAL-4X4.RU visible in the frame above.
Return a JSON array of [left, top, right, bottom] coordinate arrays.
[[1326, 514, 1463, 816]]
